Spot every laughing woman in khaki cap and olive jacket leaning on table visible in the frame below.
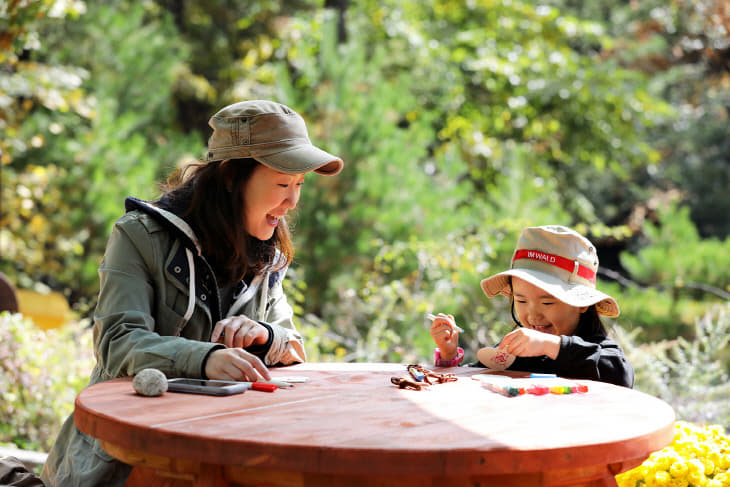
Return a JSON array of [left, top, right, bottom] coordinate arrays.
[[41, 100, 343, 487]]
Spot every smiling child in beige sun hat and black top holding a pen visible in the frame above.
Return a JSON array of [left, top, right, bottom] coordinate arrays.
[[431, 226, 634, 387]]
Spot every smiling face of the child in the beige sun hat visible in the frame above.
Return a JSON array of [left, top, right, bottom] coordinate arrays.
[[512, 277, 588, 335]]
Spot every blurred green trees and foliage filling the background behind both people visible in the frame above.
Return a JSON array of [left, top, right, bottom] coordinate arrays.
[[0, 0, 730, 448]]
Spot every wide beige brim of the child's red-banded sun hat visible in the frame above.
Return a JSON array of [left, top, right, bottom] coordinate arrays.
[[481, 269, 620, 318]]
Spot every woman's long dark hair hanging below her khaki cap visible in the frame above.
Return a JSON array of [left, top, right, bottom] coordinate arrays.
[[159, 159, 294, 285]]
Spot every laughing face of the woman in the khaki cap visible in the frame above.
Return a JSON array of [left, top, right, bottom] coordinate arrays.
[[243, 164, 304, 240]]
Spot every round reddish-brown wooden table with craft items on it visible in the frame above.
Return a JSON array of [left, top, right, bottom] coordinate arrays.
[[75, 363, 675, 487]]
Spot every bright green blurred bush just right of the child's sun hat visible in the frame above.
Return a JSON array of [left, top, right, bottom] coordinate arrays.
[[584, 205, 730, 342]]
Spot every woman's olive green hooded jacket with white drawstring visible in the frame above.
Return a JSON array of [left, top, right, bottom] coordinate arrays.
[[41, 198, 306, 487]]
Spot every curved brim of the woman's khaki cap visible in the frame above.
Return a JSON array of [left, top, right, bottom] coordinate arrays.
[[254, 145, 344, 176]]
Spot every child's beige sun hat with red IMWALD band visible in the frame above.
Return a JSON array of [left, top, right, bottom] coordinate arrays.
[[482, 225, 620, 318]]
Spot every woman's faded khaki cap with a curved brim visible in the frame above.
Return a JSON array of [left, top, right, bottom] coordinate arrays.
[[206, 100, 344, 176]]
